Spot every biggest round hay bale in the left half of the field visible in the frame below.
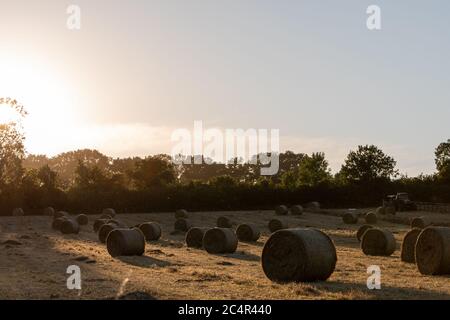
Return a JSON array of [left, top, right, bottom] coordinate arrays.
[[106, 228, 145, 257]]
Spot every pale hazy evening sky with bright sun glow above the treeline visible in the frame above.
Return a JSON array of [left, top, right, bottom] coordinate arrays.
[[0, 0, 450, 175]]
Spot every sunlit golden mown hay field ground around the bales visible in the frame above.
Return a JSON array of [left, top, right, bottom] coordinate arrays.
[[0, 210, 450, 300]]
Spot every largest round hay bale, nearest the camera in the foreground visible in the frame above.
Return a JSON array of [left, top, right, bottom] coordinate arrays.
[[261, 229, 337, 282]]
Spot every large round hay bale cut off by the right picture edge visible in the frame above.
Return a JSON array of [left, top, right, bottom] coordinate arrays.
[[416, 227, 450, 275]]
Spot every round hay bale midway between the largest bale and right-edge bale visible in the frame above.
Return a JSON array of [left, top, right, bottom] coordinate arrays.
[[361, 228, 396, 256]]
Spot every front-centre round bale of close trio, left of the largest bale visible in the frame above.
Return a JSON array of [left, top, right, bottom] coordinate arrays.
[[203, 228, 238, 254]]
